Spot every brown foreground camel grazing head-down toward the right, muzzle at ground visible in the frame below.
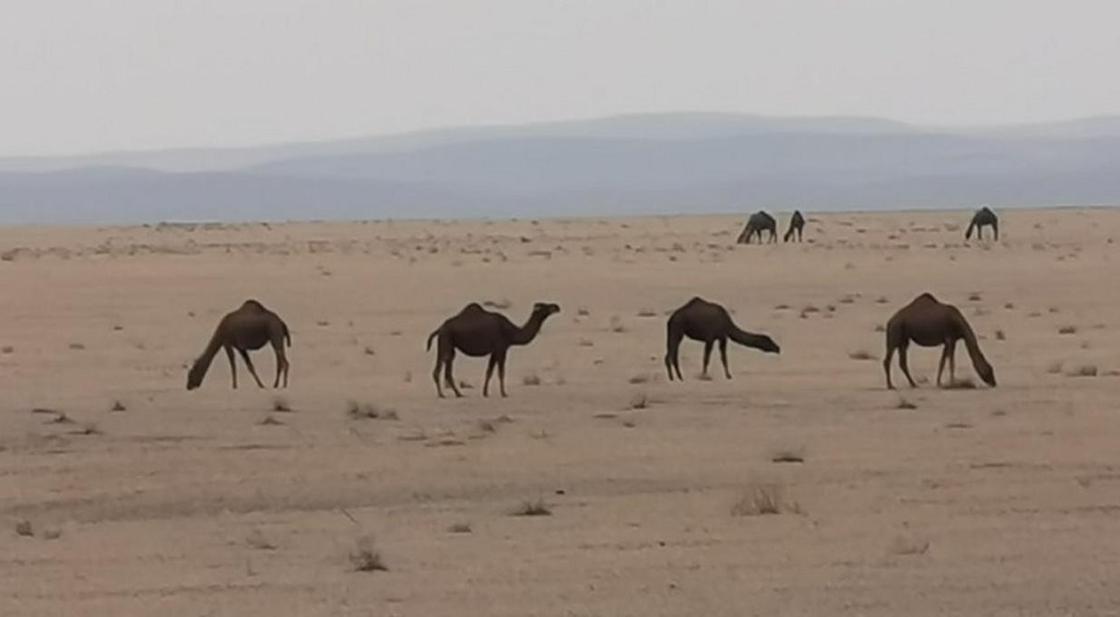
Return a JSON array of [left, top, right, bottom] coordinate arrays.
[[883, 293, 996, 390]]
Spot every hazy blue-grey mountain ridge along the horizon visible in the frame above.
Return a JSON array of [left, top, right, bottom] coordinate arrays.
[[0, 113, 1120, 224]]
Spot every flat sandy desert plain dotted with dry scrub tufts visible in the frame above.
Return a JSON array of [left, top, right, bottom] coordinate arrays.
[[0, 209, 1120, 617]]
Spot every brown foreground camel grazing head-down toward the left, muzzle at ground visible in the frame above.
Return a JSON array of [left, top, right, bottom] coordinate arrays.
[[187, 300, 291, 390]]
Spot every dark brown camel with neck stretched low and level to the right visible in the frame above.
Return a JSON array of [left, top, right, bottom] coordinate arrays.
[[665, 298, 782, 381]]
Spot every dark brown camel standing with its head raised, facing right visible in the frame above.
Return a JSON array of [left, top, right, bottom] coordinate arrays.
[[428, 302, 560, 399]]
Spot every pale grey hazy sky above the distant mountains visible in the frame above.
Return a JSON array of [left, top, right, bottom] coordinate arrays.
[[0, 0, 1120, 156]]
